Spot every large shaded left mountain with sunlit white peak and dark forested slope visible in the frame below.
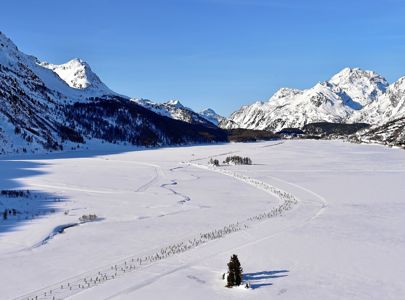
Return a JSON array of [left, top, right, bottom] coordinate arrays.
[[0, 33, 226, 154]]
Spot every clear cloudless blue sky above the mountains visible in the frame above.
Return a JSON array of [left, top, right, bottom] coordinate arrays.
[[0, 0, 405, 115]]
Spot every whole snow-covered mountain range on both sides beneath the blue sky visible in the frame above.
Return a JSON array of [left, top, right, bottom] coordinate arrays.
[[0, 32, 405, 154]]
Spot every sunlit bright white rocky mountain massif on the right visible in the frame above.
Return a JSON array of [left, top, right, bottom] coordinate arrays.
[[220, 68, 405, 131]]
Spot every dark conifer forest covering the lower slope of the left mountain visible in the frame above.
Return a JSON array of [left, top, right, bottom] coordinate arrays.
[[64, 97, 227, 146]]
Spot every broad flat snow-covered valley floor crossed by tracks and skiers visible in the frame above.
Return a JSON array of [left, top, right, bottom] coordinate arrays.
[[0, 141, 405, 299]]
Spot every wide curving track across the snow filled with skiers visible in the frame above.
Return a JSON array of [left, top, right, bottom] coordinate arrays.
[[16, 163, 298, 300]]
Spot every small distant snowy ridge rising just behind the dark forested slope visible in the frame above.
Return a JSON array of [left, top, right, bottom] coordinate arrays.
[[131, 99, 213, 127]]
